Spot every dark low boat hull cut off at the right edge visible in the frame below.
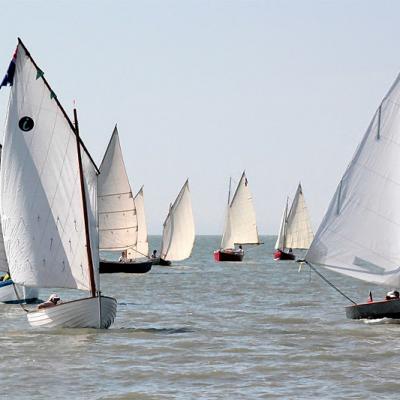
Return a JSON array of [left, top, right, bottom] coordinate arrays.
[[345, 299, 400, 319]]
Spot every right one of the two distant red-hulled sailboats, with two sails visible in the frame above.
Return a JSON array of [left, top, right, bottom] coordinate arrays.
[[274, 183, 314, 261]]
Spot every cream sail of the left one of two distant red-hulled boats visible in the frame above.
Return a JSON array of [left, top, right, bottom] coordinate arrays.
[[221, 172, 259, 249]]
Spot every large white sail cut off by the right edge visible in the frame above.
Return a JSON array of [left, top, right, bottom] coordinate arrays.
[[306, 73, 400, 287]]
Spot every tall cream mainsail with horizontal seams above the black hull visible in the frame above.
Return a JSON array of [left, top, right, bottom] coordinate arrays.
[[98, 127, 138, 251]]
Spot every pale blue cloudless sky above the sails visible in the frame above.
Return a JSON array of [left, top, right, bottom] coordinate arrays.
[[0, 0, 400, 234]]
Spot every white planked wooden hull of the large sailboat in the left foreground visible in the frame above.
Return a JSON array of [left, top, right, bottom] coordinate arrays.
[[27, 296, 117, 329]]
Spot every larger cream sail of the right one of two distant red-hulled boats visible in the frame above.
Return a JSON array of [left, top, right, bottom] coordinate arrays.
[[284, 184, 314, 249]]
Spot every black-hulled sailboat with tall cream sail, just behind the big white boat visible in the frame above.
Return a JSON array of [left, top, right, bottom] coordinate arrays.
[[97, 126, 152, 274]]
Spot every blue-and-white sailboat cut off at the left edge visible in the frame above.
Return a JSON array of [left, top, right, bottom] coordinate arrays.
[[0, 145, 39, 304]]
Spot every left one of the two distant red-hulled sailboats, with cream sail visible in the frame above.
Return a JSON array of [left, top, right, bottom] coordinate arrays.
[[214, 171, 261, 261]]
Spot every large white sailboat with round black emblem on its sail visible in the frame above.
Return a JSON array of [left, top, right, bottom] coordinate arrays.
[[0, 39, 117, 328]]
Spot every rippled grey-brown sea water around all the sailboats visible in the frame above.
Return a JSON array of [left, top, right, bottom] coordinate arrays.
[[0, 236, 400, 400]]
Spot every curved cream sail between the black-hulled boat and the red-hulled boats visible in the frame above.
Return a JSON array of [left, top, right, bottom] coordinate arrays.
[[161, 181, 195, 261]]
